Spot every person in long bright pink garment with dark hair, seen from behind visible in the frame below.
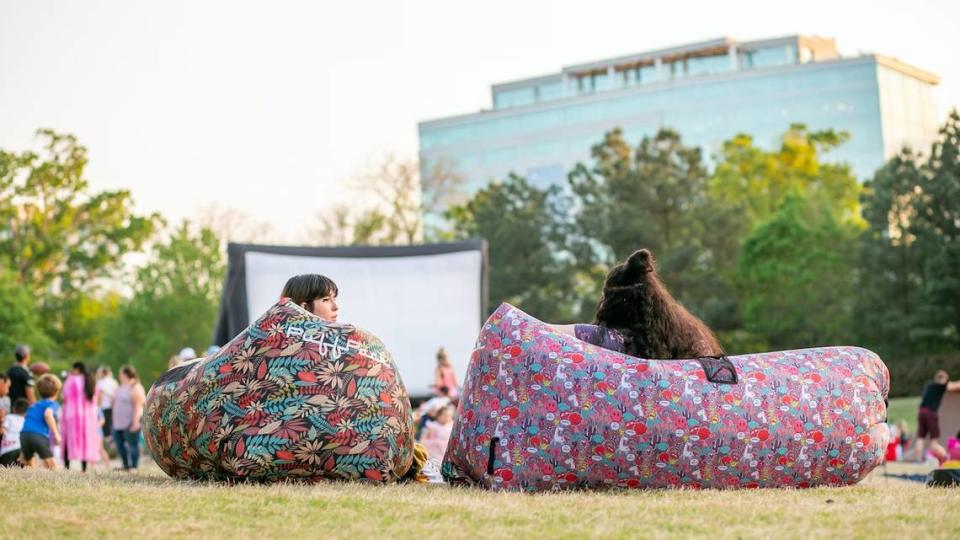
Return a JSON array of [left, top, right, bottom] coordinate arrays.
[[60, 362, 103, 471]]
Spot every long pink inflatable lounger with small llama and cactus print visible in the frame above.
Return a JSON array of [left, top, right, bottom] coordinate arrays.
[[442, 304, 890, 491]]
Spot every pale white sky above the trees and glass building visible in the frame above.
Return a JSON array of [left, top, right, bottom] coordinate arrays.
[[0, 0, 960, 240]]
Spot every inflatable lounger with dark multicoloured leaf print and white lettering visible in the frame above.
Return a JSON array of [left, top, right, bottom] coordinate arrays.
[[144, 299, 413, 482]]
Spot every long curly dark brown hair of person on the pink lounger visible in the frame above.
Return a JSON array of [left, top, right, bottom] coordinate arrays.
[[594, 249, 723, 359]]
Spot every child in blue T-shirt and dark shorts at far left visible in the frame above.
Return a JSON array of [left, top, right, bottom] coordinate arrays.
[[20, 373, 63, 469]]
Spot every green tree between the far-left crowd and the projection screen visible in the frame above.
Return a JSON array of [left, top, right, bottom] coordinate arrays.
[[101, 223, 225, 381]]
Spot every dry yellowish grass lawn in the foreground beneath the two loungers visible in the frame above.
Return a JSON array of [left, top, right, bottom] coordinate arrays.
[[0, 458, 960, 538]]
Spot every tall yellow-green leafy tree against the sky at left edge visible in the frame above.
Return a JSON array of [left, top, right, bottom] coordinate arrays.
[[0, 129, 158, 301]]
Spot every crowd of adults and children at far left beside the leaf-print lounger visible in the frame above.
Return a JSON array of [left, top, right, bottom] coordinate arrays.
[[0, 345, 146, 472]]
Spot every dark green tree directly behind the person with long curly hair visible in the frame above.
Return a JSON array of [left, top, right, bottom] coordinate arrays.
[[569, 129, 743, 328]]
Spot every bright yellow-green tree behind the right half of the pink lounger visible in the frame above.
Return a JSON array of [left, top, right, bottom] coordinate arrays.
[[704, 124, 863, 348]]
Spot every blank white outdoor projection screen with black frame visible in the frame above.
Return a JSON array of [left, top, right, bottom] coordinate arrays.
[[214, 240, 487, 397]]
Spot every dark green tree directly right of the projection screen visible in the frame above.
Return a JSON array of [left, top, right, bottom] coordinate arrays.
[[447, 174, 574, 322]]
